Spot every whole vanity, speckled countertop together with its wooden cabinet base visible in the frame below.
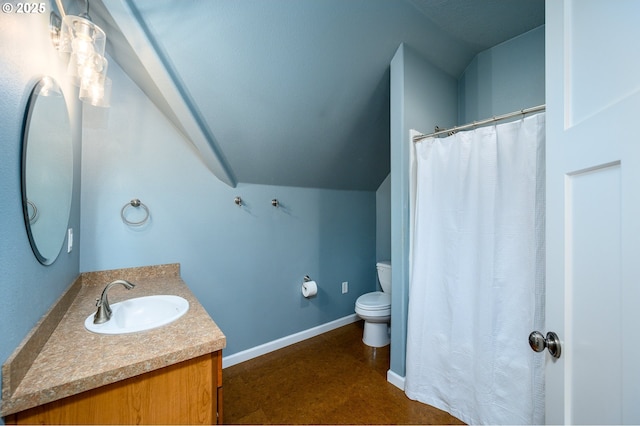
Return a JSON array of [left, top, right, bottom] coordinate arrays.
[[1, 264, 226, 424]]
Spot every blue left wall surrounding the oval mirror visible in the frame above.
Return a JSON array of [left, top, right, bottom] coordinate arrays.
[[0, 7, 81, 422]]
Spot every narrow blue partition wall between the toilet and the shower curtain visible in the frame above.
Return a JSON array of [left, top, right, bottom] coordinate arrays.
[[390, 44, 457, 377]]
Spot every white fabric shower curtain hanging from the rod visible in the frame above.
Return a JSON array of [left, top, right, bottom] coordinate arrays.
[[405, 113, 545, 424]]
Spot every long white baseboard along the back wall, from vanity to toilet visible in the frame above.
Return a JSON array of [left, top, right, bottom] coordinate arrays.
[[222, 314, 360, 368]]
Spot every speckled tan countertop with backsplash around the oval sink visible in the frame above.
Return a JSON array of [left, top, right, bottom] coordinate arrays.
[[0, 264, 226, 416]]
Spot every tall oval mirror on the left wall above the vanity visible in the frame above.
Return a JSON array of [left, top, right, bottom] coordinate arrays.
[[22, 77, 73, 265]]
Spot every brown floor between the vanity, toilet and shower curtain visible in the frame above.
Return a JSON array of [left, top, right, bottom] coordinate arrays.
[[223, 321, 463, 424]]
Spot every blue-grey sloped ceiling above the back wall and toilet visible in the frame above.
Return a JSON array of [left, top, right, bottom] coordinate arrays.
[[91, 0, 544, 190]]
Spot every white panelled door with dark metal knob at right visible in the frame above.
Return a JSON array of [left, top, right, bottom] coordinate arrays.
[[540, 0, 640, 424]]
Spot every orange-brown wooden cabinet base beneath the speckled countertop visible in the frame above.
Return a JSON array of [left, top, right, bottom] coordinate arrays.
[[5, 351, 222, 425]]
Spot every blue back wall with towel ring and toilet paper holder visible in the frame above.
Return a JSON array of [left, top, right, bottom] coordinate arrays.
[[81, 63, 376, 356]]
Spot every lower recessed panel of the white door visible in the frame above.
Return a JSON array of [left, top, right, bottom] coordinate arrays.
[[565, 163, 622, 424]]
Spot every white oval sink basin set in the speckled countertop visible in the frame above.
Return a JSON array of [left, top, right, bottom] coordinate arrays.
[[84, 295, 189, 334]]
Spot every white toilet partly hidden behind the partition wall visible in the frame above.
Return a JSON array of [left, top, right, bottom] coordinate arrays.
[[356, 261, 391, 348]]
